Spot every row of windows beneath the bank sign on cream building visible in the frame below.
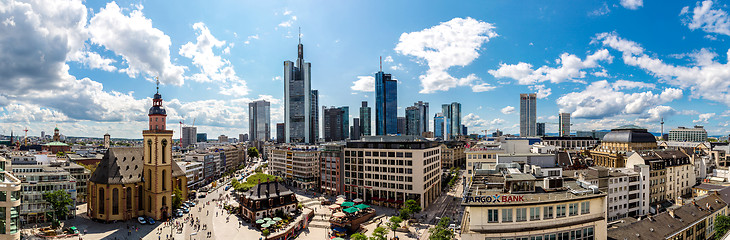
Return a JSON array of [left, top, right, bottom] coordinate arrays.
[[487, 201, 590, 223]]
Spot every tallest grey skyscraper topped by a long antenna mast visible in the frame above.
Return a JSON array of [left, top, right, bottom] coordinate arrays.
[[282, 33, 316, 143]]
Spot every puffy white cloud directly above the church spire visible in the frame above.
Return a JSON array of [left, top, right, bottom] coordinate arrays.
[[88, 2, 185, 86]]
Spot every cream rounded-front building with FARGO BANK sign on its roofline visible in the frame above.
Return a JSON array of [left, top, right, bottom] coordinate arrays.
[[461, 163, 607, 240]]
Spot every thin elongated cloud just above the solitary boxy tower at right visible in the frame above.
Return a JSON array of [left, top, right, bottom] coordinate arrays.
[[489, 49, 613, 85]]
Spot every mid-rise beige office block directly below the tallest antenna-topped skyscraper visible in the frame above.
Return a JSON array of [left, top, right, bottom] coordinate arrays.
[[269, 145, 320, 190]]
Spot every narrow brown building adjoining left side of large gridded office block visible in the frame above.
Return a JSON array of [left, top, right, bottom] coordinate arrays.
[[319, 143, 345, 196]]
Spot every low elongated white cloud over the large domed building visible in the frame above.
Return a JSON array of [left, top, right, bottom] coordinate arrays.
[[557, 80, 682, 119]]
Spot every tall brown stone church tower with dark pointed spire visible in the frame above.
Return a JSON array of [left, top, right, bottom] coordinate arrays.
[[142, 81, 173, 220]]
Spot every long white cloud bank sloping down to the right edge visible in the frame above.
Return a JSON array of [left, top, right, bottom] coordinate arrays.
[[595, 33, 730, 105]]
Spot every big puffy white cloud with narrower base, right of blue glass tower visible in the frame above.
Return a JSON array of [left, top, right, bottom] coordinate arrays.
[[395, 18, 498, 93]]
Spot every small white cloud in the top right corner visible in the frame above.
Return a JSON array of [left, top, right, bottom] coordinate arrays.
[[679, 0, 730, 35]]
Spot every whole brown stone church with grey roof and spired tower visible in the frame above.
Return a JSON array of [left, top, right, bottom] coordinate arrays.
[[87, 86, 188, 221]]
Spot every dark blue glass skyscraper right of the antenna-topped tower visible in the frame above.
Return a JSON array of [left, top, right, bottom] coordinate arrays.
[[375, 69, 398, 135]]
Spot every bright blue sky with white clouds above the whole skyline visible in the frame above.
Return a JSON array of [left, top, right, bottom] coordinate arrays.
[[0, 0, 730, 138]]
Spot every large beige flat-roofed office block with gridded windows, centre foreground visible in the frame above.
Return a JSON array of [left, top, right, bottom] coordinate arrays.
[[344, 136, 441, 209]]
